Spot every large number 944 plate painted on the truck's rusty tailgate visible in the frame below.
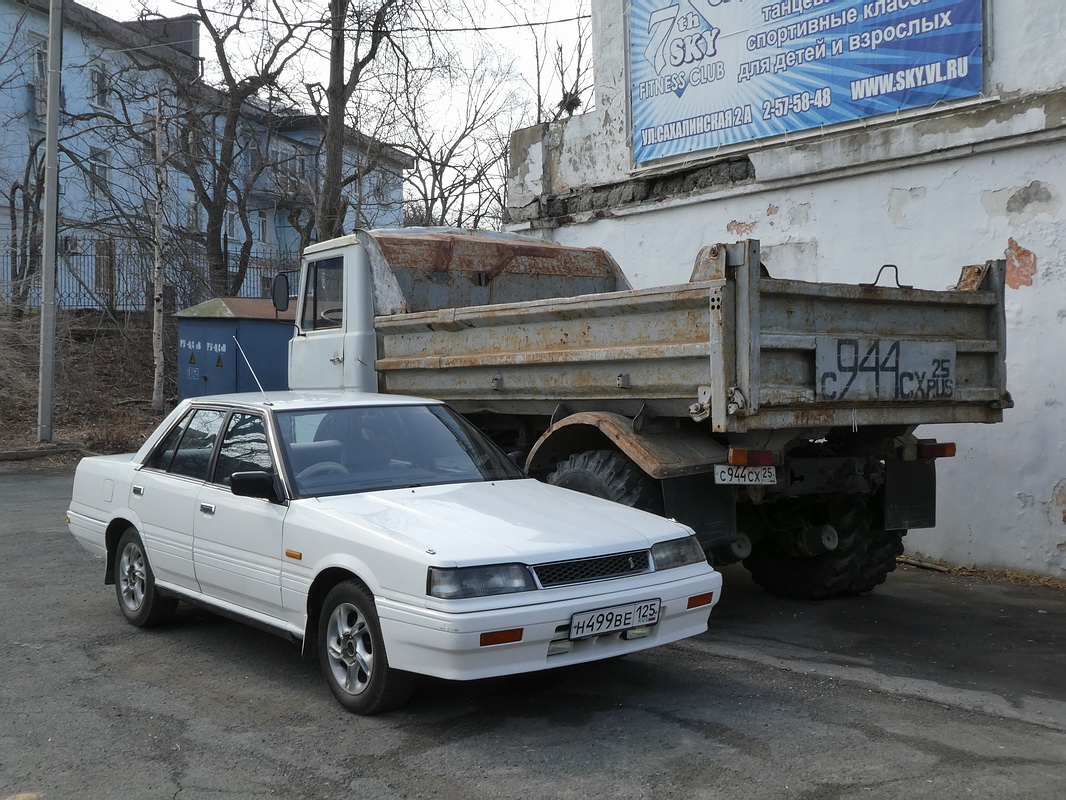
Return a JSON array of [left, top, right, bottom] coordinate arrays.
[[814, 338, 955, 402]]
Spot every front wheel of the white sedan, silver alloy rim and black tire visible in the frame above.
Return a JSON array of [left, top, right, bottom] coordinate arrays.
[[318, 580, 415, 715]]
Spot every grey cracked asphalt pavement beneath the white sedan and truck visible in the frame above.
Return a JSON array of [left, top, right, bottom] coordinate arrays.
[[0, 463, 1066, 800]]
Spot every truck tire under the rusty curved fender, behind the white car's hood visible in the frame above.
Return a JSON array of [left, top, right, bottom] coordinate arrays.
[[548, 450, 663, 514]]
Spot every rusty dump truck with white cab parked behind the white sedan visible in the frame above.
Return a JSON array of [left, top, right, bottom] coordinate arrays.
[[274, 229, 1012, 598]]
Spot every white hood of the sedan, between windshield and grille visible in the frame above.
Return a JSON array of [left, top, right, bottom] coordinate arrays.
[[309, 480, 690, 565]]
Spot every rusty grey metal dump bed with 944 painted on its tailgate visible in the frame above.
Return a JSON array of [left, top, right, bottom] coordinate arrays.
[[375, 241, 1011, 432]]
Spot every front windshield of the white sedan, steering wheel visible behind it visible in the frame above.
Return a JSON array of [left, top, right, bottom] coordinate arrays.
[[275, 405, 524, 497]]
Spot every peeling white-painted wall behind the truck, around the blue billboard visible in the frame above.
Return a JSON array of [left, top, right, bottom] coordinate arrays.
[[508, 0, 1066, 576]]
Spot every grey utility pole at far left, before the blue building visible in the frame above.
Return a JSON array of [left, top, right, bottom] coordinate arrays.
[[37, 0, 63, 442]]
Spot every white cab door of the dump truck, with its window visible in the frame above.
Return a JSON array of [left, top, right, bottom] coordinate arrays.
[[289, 255, 344, 389]]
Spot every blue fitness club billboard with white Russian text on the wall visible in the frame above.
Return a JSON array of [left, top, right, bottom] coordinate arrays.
[[628, 0, 984, 165]]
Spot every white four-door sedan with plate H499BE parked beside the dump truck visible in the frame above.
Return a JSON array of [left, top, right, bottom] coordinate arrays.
[[67, 393, 722, 714]]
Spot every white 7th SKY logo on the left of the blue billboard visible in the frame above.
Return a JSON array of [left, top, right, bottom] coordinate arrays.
[[644, 0, 730, 97]]
